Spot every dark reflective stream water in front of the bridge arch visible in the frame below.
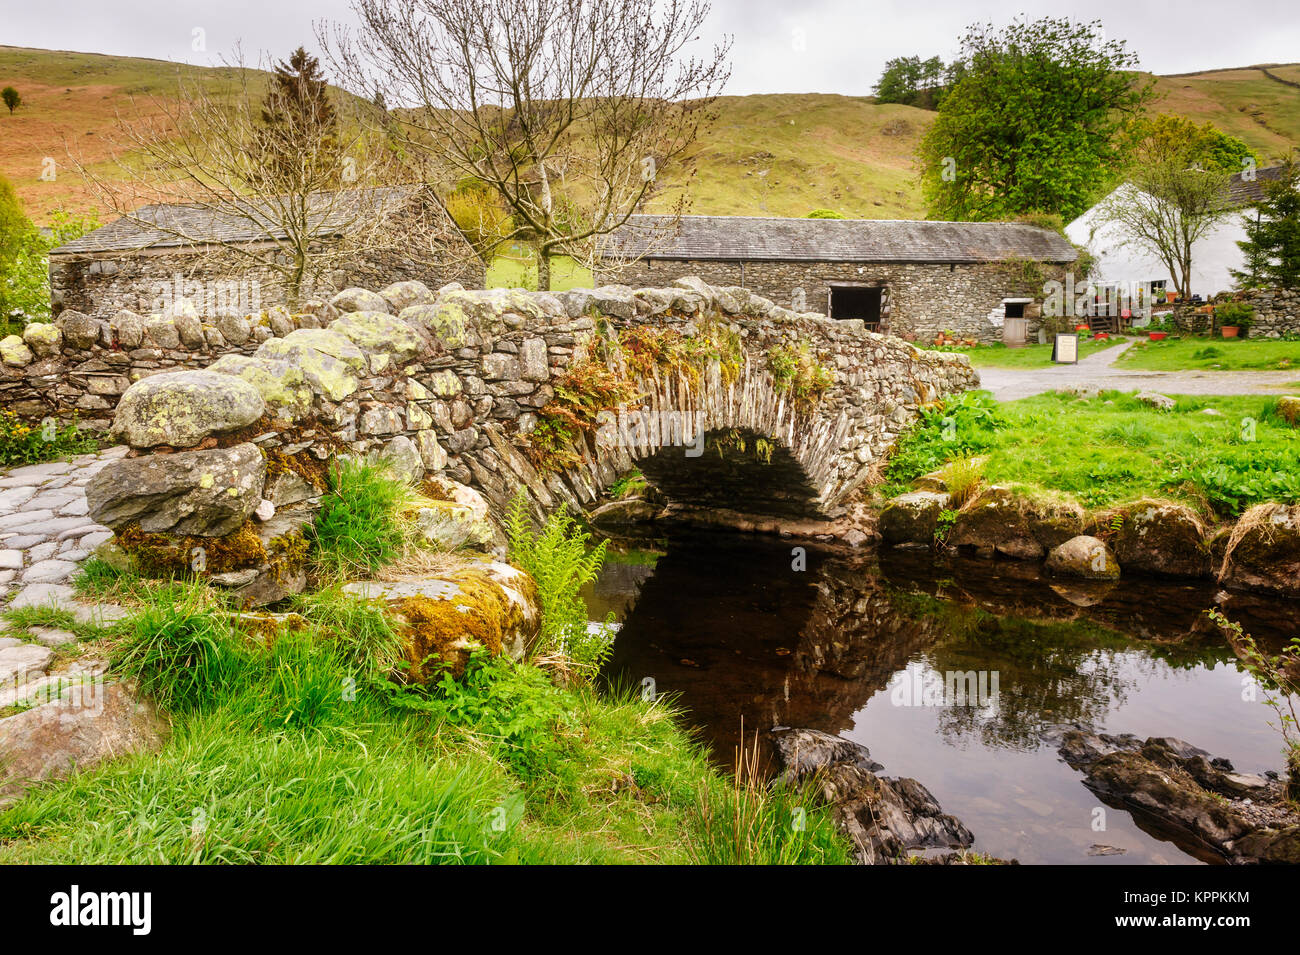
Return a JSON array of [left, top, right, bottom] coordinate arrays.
[[588, 535, 1300, 864]]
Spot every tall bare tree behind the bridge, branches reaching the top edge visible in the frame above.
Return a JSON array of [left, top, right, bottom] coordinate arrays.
[[317, 0, 731, 288]]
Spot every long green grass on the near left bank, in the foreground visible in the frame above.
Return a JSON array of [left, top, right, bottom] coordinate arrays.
[[0, 574, 849, 864]]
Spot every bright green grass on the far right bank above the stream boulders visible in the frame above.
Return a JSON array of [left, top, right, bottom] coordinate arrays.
[[883, 392, 1300, 516]]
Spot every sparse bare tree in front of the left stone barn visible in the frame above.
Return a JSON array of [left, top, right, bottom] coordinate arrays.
[[74, 50, 467, 304]]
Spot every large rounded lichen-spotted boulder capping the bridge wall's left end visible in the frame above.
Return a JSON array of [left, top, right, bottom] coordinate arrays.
[[113, 372, 267, 448]]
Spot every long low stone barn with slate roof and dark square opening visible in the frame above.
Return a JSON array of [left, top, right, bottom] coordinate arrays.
[[598, 216, 1078, 342]]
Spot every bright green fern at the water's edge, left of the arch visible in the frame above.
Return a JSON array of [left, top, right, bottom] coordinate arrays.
[[506, 494, 614, 673]]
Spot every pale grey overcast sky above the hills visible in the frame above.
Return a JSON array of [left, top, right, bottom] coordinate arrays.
[[0, 0, 1300, 95]]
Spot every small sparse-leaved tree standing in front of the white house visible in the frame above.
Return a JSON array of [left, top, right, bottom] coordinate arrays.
[[1101, 116, 1255, 296]]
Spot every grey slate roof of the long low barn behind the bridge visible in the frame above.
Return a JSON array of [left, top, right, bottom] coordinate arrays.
[[608, 216, 1078, 264]]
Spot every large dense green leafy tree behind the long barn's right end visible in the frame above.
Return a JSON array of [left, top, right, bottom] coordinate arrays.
[[919, 17, 1152, 221]]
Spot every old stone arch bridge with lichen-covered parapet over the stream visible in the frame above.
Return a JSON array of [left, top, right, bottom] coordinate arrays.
[[81, 279, 979, 571]]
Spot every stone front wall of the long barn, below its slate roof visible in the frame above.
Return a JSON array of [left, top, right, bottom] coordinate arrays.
[[598, 259, 1065, 343]]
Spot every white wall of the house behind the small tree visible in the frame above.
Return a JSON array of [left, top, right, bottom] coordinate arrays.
[[1065, 187, 1255, 298]]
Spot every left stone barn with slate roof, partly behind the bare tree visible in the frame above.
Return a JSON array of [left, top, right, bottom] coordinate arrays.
[[49, 185, 486, 318]]
